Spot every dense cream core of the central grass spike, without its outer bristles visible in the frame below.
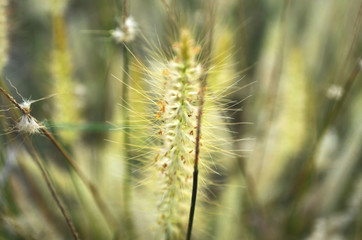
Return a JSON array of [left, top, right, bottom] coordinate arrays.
[[155, 30, 202, 239]]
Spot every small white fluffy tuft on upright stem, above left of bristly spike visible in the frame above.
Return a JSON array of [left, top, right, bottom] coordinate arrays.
[[110, 17, 138, 43]]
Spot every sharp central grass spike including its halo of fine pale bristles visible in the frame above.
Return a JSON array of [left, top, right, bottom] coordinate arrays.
[[125, 15, 240, 239]]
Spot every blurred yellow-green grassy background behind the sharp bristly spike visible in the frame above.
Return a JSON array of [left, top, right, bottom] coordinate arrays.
[[0, 0, 362, 240]]
